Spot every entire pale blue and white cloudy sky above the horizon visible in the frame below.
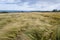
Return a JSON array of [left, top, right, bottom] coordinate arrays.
[[0, 0, 60, 11]]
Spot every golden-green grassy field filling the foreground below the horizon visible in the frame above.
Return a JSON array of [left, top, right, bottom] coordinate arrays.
[[0, 12, 60, 40]]
